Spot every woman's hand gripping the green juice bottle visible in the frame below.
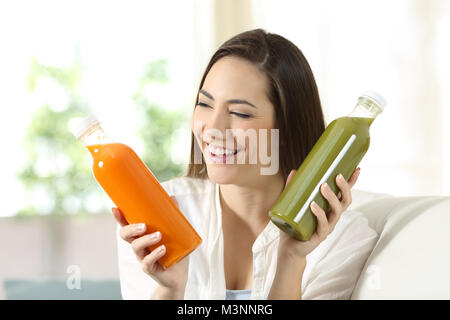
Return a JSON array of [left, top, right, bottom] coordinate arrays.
[[278, 168, 360, 259]]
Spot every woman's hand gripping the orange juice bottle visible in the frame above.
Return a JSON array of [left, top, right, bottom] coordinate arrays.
[[112, 197, 189, 299]]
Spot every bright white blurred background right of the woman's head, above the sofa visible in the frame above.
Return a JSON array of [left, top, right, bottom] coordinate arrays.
[[253, 0, 450, 196]]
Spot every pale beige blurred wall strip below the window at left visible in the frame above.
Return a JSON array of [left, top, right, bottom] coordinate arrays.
[[0, 214, 118, 283]]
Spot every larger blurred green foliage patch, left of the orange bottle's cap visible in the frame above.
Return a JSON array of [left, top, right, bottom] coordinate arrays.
[[18, 58, 99, 215]]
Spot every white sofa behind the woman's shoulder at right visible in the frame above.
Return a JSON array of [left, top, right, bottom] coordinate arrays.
[[348, 189, 450, 300]]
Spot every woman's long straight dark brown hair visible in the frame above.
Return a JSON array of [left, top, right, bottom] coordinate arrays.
[[186, 29, 325, 179]]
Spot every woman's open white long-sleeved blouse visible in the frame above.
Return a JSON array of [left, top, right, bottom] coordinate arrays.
[[117, 177, 378, 300]]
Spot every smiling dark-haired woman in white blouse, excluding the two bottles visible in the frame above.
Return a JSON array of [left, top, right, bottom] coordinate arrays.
[[113, 29, 377, 299]]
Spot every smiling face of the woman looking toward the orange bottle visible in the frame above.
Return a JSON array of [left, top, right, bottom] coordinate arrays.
[[192, 56, 278, 185]]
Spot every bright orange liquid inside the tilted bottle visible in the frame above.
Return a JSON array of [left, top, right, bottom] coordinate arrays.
[[87, 143, 202, 269]]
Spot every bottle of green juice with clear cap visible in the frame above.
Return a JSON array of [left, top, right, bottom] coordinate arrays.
[[269, 91, 386, 240]]
